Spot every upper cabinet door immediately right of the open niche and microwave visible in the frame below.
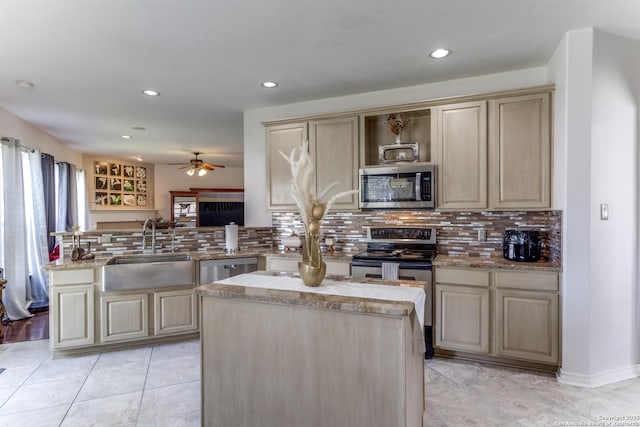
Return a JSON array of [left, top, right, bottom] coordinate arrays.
[[432, 101, 487, 209]]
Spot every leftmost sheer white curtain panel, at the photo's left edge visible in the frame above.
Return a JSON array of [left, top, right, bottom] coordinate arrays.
[[0, 138, 32, 319]]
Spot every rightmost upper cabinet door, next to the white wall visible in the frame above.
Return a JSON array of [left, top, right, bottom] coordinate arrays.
[[489, 93, 551, 209]]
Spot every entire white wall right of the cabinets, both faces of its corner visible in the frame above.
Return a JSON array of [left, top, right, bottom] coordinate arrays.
[[549, 29, 640, 387]]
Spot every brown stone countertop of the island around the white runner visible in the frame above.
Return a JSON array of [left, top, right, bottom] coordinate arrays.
[[195, 272, 426, 316]]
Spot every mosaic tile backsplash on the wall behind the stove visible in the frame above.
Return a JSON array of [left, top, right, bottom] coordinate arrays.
[[272, 210, 562, 264]]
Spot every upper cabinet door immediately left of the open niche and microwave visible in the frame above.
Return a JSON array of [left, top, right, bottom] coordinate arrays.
[[309, 116, 359, 210]]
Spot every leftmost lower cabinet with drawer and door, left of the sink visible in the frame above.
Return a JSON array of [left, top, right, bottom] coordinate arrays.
[[49, 269, 96, 349]]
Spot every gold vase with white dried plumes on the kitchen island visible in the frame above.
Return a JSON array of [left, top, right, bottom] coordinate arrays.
[[280, 141, 358, 286]]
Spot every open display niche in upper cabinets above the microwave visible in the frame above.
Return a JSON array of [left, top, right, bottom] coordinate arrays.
[[360, 106, 432, 167]]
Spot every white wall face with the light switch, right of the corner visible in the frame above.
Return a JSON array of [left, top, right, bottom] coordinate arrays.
[[590, 31, 640, 379]]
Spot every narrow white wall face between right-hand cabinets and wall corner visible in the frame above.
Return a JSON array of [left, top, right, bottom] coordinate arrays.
[[549, 29, 593, 383]]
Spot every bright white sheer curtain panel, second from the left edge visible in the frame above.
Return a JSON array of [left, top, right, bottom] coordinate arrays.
[[22, 150, 49, 308]]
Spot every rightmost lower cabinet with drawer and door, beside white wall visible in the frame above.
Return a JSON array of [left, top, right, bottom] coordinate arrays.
[[495, 272, 560, 364]]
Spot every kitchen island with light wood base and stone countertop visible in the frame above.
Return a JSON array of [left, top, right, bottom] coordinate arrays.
[[196, 273, 425, 427]]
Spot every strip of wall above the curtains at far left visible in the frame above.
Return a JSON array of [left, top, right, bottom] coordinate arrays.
[[0, 107, 82, 167]]
